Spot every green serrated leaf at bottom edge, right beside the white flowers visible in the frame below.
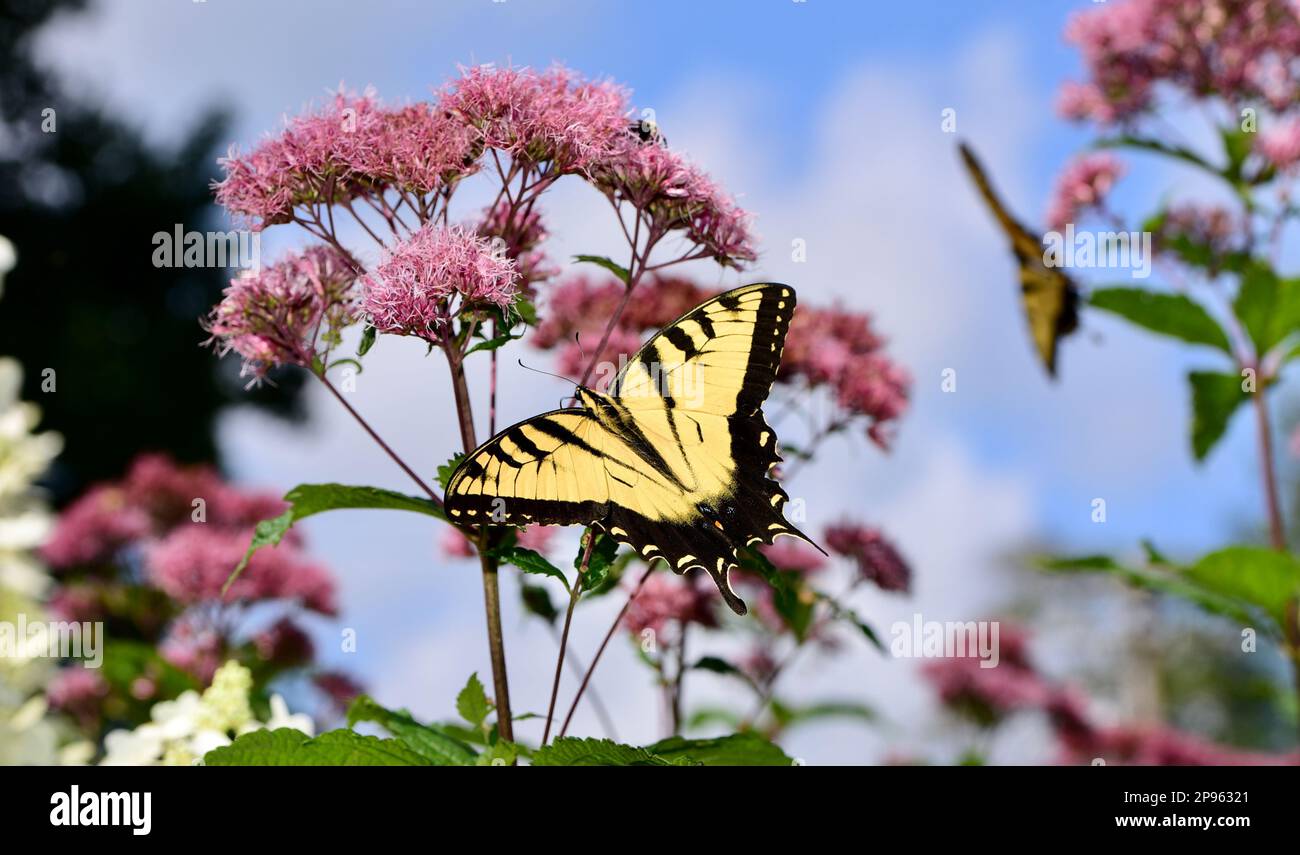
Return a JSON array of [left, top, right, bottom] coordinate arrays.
[[203, 728, 433, 765]]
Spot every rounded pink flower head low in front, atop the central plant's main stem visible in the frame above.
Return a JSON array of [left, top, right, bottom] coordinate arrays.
[[363, 223, 519, 343]]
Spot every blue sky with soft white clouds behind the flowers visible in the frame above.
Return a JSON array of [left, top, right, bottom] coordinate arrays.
[[32, 0, 1279, 763]]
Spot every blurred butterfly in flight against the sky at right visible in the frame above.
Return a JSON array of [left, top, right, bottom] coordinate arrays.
[[961, 143, 1079, 377]]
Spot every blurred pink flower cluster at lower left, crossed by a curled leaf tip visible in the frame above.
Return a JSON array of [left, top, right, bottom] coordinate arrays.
[[146, 525, 338, 615]]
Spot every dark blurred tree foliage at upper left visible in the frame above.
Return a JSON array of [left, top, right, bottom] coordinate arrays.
[[0, 0, 299, 500]]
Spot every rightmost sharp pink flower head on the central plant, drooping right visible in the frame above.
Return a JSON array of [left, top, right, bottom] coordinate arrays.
[[592, 133, 758, 268]]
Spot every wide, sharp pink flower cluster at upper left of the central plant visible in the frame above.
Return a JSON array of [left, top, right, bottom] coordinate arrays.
[[215, 92, 476, 230]]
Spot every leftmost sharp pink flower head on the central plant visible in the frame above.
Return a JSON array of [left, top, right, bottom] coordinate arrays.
[[205, 247, 358, 382]]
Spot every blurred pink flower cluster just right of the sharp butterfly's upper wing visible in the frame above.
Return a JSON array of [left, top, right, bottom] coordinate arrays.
[[780, 305, 911, 447]]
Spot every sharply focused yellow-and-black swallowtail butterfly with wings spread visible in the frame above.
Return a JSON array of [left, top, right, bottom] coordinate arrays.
[[446, 283, 820, 615]]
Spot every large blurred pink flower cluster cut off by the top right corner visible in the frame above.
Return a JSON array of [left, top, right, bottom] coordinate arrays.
[[1058, 0, 1300, 125]]
